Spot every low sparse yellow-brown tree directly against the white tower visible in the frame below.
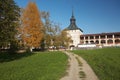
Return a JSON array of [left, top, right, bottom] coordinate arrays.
[[47, 24, 71, 49]]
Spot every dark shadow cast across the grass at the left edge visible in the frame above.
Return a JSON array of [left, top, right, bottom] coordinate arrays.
[[0, 52, 34, 63]]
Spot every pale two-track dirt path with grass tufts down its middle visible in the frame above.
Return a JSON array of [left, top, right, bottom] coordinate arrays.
[[60, 51, 99, 80]]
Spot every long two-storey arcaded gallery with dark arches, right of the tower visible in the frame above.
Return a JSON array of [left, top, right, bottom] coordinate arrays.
[[80, 32, 120, 46]]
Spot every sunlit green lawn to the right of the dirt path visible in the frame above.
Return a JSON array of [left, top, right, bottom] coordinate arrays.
[[73, 48, 120, 80]]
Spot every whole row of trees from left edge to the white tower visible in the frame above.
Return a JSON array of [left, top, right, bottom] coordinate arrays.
[[0, 0, 70, 52]]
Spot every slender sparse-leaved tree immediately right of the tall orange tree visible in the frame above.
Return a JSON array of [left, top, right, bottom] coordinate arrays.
[[41, 11, 53, 48]]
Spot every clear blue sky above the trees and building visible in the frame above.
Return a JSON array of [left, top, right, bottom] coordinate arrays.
[[14, 0, 120, 34]]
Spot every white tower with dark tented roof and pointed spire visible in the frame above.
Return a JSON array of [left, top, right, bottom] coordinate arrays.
[[66, 11, 83, 47]]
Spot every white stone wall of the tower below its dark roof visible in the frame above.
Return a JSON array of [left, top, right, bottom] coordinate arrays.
[[67, 30, 83, 47]]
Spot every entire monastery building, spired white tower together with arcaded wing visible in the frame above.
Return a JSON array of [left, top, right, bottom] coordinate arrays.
[[66, 12, 120, 47]]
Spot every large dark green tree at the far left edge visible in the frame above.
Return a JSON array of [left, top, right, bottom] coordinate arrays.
[[0, 0, 20, 48]]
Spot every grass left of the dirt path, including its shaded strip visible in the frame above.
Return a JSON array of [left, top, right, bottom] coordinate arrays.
[[0, 51, 68, 80]]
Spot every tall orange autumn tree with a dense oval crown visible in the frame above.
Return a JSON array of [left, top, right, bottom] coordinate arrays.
[[20, 2, 43, 51]]
